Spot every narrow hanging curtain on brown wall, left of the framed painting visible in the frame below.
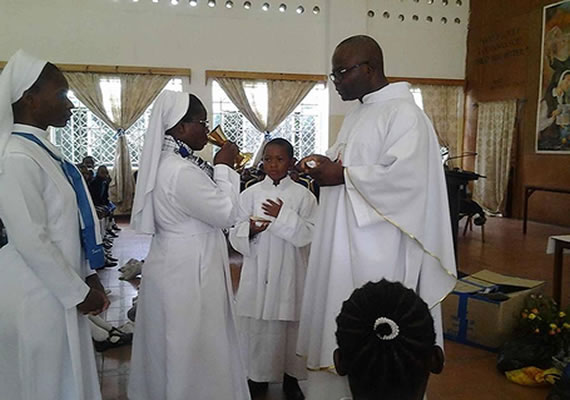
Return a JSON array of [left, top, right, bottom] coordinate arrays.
[[473, 100, 517, 214]]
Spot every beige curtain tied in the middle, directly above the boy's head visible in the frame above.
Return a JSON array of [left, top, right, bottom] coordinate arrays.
[[216, 78, 316, 165]]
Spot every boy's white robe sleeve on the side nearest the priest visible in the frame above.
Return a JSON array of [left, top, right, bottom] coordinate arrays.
[[267, 193, 317, 247]]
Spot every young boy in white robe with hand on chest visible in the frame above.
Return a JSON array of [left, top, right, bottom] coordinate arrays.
[[230, 138, 317, 399]]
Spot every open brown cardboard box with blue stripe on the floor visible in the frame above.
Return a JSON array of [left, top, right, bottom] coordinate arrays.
[[442, 270, 544, 350]]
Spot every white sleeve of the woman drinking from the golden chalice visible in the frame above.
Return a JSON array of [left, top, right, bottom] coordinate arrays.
[[173, 164, 240, 228]]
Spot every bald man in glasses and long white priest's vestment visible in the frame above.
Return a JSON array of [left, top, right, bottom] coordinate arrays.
[[297, 36, 456, 400]]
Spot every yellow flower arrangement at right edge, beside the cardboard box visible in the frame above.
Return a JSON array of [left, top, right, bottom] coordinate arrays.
[[518, 294, 570, 357]]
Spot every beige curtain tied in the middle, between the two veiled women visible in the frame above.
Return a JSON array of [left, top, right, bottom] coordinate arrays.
[[65, 72, 171, 214]]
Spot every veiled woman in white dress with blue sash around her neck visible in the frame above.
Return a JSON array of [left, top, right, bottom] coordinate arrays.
[[0, 50, 109, 400]]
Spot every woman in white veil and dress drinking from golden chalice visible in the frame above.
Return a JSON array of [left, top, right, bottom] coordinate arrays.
[[128, 91, 250, 400]]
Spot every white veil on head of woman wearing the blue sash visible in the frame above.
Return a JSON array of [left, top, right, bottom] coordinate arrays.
[[0, 50, 47, 174]]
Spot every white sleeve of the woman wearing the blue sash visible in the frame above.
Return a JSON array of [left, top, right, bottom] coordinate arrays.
[[0, 154, 89, 308]]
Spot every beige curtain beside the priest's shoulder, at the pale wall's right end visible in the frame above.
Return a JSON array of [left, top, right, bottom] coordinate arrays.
[[415, 85, 465, 167]]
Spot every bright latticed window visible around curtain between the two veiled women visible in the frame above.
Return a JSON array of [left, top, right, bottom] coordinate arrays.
[[51, 77, 182, 167]]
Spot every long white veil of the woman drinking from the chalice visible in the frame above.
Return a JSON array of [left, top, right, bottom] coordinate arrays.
[[131, 91, 190, 234]]
